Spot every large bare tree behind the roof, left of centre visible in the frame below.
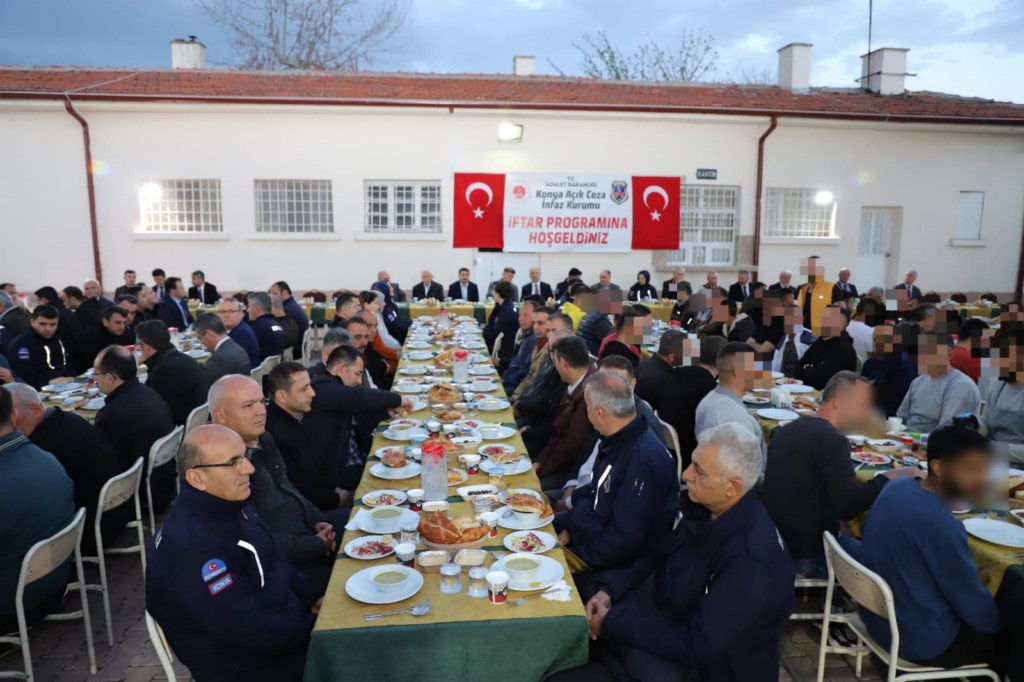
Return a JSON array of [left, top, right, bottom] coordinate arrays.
[[199, 0, 412, 70]]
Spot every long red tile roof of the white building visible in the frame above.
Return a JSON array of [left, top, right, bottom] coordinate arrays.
[[0, 68, 1024, 125]]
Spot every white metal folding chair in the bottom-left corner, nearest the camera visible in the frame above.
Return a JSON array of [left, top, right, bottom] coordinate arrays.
[[0, 508, 96, 682]]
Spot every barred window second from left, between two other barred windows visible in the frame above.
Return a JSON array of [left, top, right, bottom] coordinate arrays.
[[256, 180, 334, 233]]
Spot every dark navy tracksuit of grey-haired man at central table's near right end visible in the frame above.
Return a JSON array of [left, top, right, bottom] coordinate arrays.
[[597, 492, 794, 682]]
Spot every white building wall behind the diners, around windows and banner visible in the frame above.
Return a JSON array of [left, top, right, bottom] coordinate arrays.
[[0, 102, 1024, 292]]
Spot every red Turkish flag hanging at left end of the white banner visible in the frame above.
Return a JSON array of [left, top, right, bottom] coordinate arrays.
[[452, 173, 505, 249]]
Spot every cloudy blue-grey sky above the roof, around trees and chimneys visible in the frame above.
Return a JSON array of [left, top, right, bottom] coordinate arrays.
[[0, 0, 1024, 102]]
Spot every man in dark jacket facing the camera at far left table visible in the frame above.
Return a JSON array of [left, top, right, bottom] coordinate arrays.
[[4, 305, 75, 389]]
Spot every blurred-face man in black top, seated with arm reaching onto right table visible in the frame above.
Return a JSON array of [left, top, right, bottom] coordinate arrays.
[[761, 372, 918, 578]]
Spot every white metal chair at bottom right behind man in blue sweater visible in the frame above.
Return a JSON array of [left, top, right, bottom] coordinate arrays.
[[818, 530, 999, 682]]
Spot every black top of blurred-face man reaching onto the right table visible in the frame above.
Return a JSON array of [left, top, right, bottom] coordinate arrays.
[[761, 417, 889, 559]]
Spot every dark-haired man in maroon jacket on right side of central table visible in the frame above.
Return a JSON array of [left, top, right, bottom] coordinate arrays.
[[532, 336, 594, 491]]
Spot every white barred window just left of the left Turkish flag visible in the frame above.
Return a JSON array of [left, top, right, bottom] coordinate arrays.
[[366, 180, 441, 235]]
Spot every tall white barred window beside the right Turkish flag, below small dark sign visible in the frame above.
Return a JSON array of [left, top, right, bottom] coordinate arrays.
[[667, 184, 739, 266]]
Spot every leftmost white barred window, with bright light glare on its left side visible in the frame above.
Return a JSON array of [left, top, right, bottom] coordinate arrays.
[[138, 179, 224, 232]]
